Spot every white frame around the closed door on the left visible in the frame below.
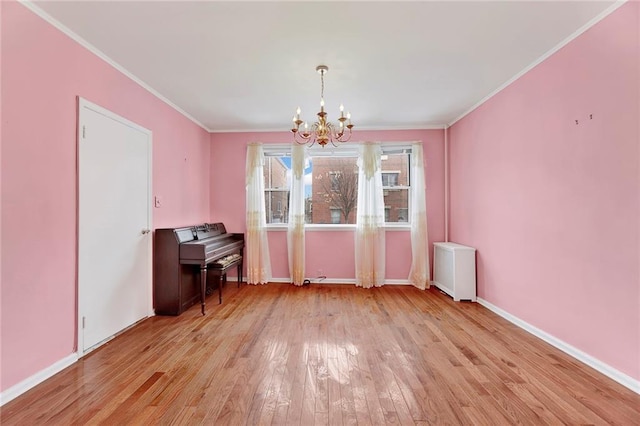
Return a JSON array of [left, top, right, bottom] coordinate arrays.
[[75, 96, 155, 358]]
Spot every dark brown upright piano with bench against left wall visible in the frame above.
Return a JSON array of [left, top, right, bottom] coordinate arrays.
[[153, 223, 244, 315]]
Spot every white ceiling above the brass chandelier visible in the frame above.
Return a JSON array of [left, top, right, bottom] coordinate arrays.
[[35, 1, 614, 131]]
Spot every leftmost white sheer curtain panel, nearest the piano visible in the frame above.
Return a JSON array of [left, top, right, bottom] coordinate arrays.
[[245, 144, 271, 284]]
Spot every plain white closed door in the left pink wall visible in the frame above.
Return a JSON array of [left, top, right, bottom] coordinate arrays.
[[78, 98, 152, 355]]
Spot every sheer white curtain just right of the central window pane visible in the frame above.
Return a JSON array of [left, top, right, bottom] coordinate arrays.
[[356, 143, 385, 288]]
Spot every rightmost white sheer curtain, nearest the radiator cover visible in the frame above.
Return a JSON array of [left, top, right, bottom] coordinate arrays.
[[409, 142, 429, 290]]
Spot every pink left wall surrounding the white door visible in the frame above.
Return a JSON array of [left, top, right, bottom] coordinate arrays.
[[0, 2, 210, 390]]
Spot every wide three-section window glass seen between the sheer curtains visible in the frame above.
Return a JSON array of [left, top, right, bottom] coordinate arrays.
[[264, 143, 411, 225]]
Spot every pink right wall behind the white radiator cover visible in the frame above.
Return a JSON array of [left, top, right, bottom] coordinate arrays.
[[450, 2, 640, 380]]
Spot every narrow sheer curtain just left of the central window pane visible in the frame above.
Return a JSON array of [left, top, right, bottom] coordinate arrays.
[[287, 144, 306, 285]]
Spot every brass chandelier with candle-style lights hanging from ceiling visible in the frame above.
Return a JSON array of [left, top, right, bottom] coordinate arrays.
[[291, 65, 353, 148]]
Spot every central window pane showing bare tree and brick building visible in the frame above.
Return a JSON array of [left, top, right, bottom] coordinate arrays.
[[311, 157, 358, 224]]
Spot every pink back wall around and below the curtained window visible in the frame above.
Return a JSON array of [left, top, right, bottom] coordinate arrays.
[[211, 130, 444, 282]]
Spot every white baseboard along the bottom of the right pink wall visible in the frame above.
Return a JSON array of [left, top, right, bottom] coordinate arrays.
[[477, 297, 640, 394]]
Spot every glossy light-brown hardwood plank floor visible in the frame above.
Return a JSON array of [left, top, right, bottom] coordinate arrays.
[[0, 284, 640, 425]]
